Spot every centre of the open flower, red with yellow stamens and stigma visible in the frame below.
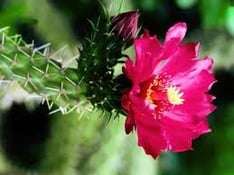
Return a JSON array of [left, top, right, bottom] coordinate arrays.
[[144, 74, 184, 113]]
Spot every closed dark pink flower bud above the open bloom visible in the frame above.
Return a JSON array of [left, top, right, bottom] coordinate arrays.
[[111, 11, 139, 40]]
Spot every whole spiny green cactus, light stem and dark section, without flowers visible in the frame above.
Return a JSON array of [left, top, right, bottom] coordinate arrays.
[[0, 9, 129, 116]]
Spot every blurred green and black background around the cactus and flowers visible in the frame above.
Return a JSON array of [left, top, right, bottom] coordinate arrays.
[[0, 0, 234, 175]]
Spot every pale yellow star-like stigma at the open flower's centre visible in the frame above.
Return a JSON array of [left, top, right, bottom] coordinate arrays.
[[167, 86, 184, 105]]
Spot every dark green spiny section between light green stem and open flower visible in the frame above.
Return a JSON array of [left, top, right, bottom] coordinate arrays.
[[77, 18, 126, 114]]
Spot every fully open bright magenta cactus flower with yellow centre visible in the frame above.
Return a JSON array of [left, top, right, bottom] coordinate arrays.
[[121, 22, 215, 158]]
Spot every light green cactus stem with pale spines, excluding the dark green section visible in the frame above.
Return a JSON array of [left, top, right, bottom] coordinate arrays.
[[0, 28, 90, 113]]
